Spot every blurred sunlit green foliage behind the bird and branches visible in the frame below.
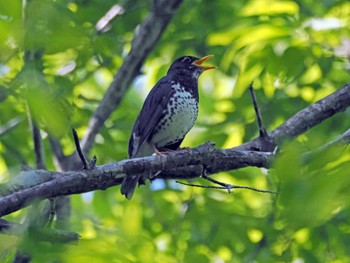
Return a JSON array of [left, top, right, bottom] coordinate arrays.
[[0, 0, 350, 262]]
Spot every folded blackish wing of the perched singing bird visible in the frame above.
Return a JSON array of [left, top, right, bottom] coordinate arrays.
[[129, 76, 174, 157]]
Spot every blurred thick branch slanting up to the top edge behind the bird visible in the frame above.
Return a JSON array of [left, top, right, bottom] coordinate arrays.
[[81, 0, 182, 156]]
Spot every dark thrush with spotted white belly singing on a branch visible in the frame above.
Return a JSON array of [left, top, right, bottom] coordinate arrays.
[[120, 55, 216, 200]]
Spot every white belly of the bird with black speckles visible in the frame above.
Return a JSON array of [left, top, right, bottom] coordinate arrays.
[[151, 85, 198, 148]]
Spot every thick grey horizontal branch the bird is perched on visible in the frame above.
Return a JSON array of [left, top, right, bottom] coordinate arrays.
[[0, 143, 272, 216]]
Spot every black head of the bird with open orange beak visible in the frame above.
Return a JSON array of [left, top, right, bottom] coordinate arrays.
[[168, 55, 216, 79]]
